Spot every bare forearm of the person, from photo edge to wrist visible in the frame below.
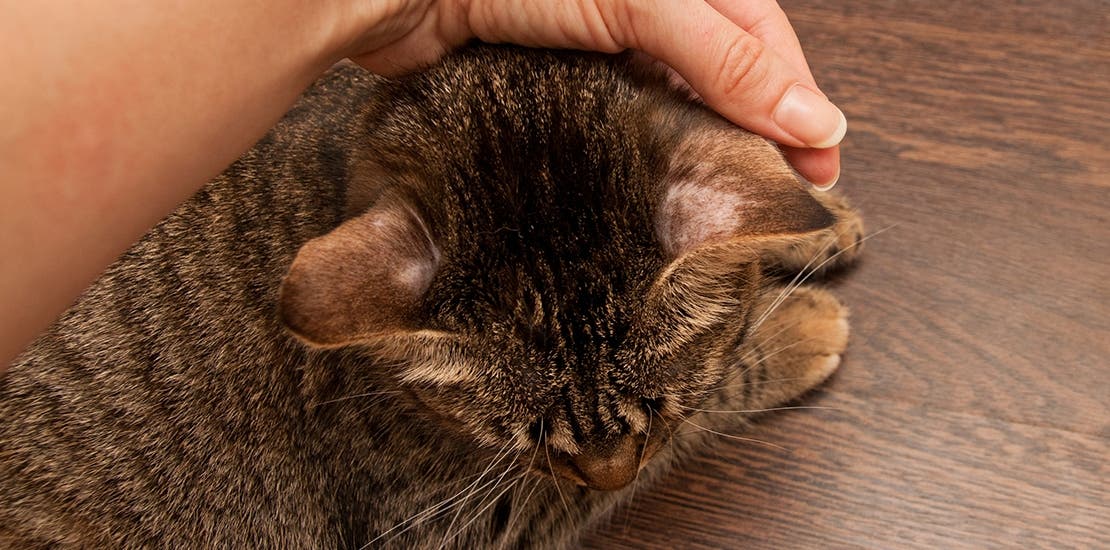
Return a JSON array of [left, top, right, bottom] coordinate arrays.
[[0, 0, 352, 371]]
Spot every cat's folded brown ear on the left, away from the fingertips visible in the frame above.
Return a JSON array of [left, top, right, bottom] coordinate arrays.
[[280, 197, 441, 347]]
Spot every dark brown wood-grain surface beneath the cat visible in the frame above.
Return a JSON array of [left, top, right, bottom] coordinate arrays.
[[583, 0, 1110, 549]]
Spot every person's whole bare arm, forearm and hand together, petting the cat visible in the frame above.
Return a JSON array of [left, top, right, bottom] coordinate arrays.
[[0, 0, 845, 371]]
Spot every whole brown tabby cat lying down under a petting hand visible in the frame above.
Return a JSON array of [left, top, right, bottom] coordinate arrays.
[[0, 46, 862, 549]]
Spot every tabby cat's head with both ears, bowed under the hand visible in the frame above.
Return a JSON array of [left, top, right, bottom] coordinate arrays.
[[281, 48, 834, 489]]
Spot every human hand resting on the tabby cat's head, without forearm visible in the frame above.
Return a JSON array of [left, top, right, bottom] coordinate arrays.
[[335, 0, 847, 188]]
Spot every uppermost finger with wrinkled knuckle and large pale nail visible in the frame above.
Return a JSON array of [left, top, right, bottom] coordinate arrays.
[[626, 0, 848, 149]]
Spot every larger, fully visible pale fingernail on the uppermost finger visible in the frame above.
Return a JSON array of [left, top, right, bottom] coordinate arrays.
[[771, 84, 848, 149]]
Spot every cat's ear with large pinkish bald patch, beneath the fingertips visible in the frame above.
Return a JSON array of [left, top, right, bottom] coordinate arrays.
[[655, 128, 836, 260]]
